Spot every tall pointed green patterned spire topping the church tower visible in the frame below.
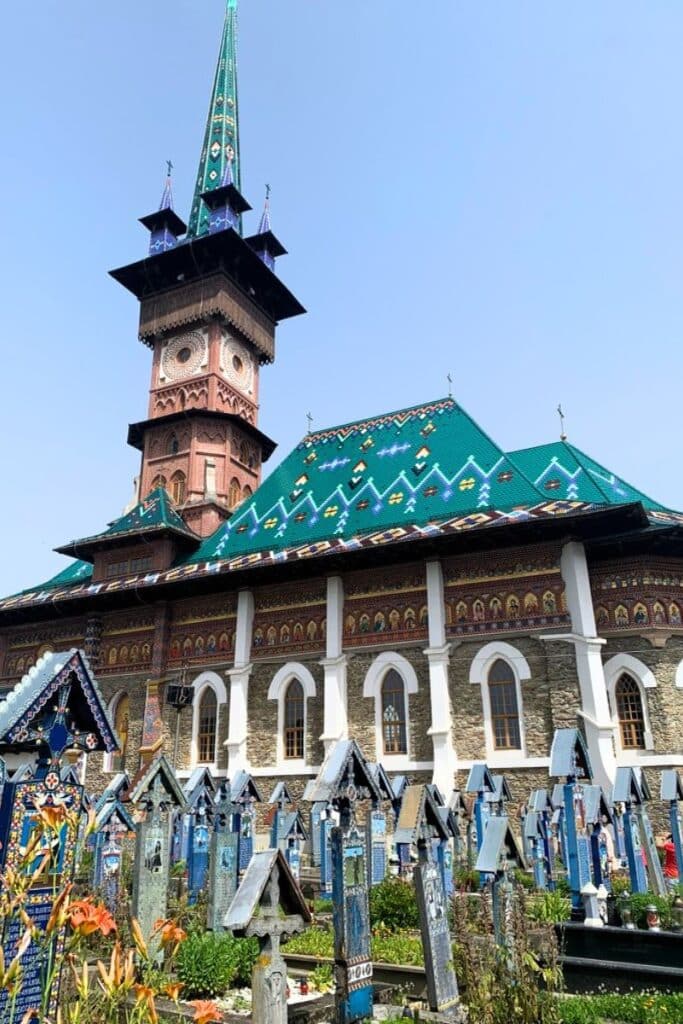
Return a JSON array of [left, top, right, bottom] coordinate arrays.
[[188, 0, 240, 236]]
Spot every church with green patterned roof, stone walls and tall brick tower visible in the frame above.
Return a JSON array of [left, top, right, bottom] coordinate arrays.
[[0, 0, 683, 797]]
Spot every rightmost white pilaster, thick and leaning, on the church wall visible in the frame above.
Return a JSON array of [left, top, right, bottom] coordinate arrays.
[[548, 541, 616, 785]]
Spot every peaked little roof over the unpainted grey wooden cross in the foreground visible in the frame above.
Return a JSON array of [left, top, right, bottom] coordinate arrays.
[[223, 850, 311, 933]]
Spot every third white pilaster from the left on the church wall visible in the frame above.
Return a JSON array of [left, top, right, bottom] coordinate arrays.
[[424, 561, 456, 800]]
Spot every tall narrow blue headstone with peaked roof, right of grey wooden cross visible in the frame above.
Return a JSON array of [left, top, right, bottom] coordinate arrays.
[[309, 739, 381, 1024]]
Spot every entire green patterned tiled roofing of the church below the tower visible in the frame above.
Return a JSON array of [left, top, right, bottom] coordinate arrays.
[[5, 397, 683, 610]]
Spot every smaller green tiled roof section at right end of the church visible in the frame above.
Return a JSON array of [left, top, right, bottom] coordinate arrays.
[[509, 441, 665, 511]]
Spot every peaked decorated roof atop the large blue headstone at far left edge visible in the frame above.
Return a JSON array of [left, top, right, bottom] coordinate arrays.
[[0, 647, 121, 757]]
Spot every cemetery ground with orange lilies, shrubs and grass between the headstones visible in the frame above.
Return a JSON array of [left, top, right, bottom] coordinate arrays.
[[7, 808, 683, 1024]]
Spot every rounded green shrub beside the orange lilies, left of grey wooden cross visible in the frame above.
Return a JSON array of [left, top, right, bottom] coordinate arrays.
[[176, 932, 240, 999]]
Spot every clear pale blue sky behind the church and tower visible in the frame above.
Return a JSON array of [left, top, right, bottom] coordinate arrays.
[[0, 0, 683, 594]]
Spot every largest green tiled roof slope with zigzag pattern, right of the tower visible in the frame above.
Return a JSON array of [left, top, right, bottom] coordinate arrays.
[[191, 398, 547, 562]]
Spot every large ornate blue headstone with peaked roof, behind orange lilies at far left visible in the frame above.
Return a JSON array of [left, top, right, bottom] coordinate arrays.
[[0, 648, 119, 1024]]
